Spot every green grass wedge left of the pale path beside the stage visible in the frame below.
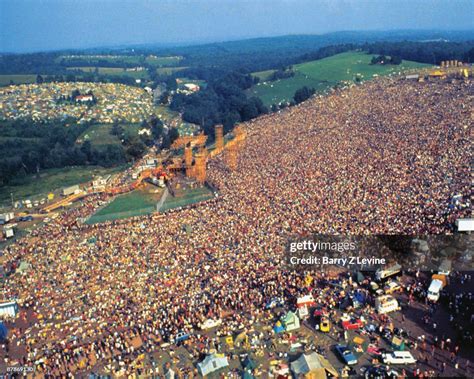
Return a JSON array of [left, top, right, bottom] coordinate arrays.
[[86, 190, 162, 224]]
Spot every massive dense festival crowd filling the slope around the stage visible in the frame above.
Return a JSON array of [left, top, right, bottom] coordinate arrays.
[[1, 79, 472, 377]]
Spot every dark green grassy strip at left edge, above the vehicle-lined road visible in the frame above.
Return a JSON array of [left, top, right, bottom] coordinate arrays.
[[0, 166, 125, 205]]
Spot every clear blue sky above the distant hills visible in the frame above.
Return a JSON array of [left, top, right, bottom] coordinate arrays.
[[0, 0, 474, 52]]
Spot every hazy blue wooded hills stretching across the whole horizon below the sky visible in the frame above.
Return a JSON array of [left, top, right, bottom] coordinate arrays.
[[0, 30, 474, 80]]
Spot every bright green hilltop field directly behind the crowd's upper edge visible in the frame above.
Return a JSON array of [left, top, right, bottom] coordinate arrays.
[[247, 52, 429, 106]]
